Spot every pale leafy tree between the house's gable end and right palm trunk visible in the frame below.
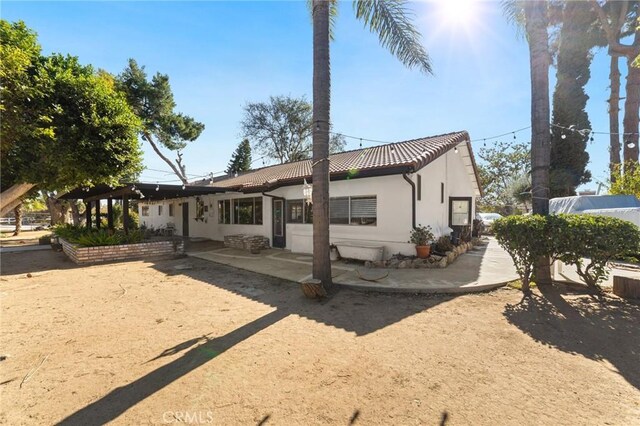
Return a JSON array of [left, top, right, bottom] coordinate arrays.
[[478, 141, 531, 214]]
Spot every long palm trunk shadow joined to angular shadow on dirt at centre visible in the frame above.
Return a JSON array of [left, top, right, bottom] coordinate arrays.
[[60, 258, 453, 425]]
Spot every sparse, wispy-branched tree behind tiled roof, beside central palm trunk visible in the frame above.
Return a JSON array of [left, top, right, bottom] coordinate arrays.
[[240, 96, 345, 164]]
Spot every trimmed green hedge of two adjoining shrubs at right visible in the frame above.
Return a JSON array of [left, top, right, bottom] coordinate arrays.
[[493, 214, 640, 292]]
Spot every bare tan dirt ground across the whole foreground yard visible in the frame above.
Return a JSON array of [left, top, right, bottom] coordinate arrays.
[[0, 251, 640, 425]]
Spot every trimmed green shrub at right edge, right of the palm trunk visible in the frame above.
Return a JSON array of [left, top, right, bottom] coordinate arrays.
[[549, 214, 640, 289]]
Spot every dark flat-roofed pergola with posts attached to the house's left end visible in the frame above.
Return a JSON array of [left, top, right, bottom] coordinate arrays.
[[58, 182, 229, 232]]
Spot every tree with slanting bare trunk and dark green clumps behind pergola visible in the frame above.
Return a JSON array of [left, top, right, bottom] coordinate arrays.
[[117, 59, 204, 184]]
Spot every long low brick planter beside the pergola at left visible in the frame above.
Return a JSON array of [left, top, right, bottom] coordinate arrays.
[[59, 238, 184, 265]]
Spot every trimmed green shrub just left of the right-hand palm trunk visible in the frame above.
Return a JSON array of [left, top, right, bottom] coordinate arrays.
[[493, 215, 552, 293]]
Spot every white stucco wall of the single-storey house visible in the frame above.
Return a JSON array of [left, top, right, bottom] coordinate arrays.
[[139, 146, 476, 257]]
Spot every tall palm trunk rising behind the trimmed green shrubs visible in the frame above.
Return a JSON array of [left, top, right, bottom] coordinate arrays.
[[525, 0, 551, 284]]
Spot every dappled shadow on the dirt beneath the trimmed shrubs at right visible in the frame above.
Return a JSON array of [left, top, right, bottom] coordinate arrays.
[[504, 285, 640, 389]]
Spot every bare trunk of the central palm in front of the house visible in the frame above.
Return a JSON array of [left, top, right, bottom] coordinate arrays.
[[312, 0, 333, 287]]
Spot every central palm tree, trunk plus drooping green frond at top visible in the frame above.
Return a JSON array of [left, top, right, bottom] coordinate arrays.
[[311, 0, 431, 287]]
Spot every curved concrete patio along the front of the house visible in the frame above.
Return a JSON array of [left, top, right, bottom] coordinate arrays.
[[187, 239, 518, 293]]
